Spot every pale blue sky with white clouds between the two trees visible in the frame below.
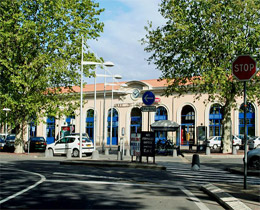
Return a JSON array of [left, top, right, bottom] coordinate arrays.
[[86, 0, 165, 84]]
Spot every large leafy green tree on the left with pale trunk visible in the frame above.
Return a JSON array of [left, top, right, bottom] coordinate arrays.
[[0, 0, 103, 152]]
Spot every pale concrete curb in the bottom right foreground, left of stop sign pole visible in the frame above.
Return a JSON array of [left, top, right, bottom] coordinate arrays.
[[201, 184, 250, 210]]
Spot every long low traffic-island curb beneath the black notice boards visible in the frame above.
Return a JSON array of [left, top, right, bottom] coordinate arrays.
[[60, 160, 166, 170]]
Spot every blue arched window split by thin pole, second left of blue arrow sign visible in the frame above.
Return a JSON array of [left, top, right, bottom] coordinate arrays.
[[107, 108, 118, 145]]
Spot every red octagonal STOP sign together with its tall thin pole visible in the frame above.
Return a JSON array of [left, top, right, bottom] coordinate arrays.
[[232, 55, 256, 189]]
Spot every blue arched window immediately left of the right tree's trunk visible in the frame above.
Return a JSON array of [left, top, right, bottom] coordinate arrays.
[[209, 104, 223, 136]]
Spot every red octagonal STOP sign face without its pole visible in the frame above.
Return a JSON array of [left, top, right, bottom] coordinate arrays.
[[232, 55, 256, 81]]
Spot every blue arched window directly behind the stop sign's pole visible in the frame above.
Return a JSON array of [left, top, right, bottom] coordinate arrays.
[[239, 103, 255, 136]]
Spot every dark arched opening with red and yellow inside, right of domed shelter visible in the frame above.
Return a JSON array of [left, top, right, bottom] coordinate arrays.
[[180, 105, 195, 145]]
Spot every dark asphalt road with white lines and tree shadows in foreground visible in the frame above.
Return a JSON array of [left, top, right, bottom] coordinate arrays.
[[0, 153, 223, 210]]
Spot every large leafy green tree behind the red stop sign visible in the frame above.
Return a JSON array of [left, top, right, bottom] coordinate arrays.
[[142, 0, 260, 153]]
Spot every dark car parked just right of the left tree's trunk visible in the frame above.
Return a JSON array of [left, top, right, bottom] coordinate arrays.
[[25, 137, 47, 152]]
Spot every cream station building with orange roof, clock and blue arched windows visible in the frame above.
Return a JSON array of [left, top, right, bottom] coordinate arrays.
[[5, 79, 260, 146]]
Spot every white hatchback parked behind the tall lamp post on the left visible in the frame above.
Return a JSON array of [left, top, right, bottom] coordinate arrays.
[[47, 136, 94, 157]]
